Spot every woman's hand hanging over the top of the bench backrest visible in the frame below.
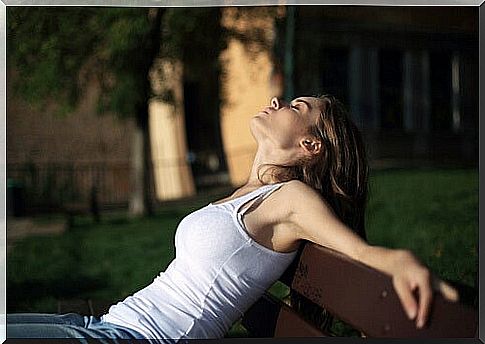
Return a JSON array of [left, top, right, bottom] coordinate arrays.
[[386, 250, 459, 328]]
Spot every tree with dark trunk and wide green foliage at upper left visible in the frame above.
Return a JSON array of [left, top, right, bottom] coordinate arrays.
[[7, 7, 274, 215]]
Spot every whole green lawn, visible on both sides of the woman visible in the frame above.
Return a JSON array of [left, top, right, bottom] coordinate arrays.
[[7, 169, 478, 334]]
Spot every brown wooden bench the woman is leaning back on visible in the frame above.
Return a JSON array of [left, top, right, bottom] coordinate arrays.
[[242, 243, 478, 338]]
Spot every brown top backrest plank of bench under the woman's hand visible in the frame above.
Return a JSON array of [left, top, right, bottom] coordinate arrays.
[[291, 244, 478, 338]]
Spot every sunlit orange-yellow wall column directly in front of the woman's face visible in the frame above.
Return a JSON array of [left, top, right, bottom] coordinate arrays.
[[221, 7, 276, 186]]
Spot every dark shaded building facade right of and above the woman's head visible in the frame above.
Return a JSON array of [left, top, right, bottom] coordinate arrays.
[[279, 6, 479, 169]]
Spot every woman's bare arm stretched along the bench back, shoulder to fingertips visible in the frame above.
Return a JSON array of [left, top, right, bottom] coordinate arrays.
[[287, 181, 458, 328]]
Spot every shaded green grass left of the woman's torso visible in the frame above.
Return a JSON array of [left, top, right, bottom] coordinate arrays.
[[7, 208, 200, 312]]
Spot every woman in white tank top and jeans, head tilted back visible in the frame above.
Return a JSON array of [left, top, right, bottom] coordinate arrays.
[[7, 96, 458, 342]]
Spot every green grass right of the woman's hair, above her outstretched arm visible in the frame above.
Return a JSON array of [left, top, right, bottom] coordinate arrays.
[[367, 170, 479, 286]]
